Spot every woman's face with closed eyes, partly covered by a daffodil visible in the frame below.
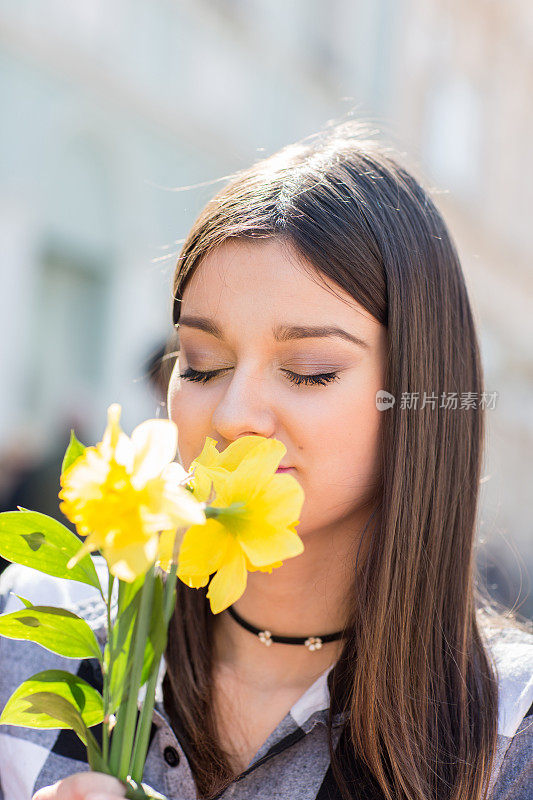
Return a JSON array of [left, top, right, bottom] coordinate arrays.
[[168, 239, 386, 536]]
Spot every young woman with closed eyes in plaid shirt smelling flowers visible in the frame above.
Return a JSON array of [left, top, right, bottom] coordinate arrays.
[[0, 124, 533, 800]]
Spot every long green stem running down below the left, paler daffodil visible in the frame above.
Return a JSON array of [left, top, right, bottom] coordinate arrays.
[[113, 566, 154, 780]]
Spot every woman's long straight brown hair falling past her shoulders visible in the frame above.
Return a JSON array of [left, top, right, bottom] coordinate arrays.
[[164, 123, 528, 800]]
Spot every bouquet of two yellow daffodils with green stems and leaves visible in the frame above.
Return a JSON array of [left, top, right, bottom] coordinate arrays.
[[0, 404, 304, 798]]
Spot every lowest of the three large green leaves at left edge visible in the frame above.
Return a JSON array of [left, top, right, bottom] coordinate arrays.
[[0, 669, 104, 732]]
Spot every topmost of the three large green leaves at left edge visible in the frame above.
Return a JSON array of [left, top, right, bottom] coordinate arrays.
[[0, 509, 101, 591]]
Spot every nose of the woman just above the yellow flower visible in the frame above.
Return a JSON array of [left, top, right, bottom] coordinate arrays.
[[212, 369, 276, 444]]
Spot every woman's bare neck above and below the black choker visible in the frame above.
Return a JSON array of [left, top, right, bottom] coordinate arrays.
[[210, 520, 368, 686]]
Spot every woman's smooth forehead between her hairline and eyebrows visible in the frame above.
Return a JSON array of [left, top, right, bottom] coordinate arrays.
[[181, 239, 379, 328]]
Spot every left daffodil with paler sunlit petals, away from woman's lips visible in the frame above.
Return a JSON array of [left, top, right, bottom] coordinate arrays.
[[59, 404, 205, 581]]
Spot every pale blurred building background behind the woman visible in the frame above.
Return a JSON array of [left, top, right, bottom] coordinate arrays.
[[0, 0, 533, 616]]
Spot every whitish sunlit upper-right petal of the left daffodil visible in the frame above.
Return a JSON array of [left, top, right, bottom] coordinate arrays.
[[131, 419, 178, 489]]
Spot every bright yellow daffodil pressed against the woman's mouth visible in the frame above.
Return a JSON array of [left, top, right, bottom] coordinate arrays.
[[178, 436, 304, 614]]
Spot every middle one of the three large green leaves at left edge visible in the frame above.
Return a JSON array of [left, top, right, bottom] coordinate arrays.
[[0, 606, 102, 661]]
